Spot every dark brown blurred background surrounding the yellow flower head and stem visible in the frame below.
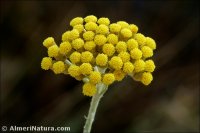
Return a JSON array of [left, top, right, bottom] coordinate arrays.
[[0, 0, 200, 133]]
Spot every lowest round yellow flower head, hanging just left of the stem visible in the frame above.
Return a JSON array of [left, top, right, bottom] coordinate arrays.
[[82, 83, 97, 97]]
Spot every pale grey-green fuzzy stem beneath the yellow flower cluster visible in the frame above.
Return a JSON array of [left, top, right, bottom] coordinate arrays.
[[83, 83, 107, 133]]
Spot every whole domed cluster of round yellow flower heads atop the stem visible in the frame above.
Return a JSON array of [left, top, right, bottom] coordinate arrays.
[[41, 15, 156, 96]]
